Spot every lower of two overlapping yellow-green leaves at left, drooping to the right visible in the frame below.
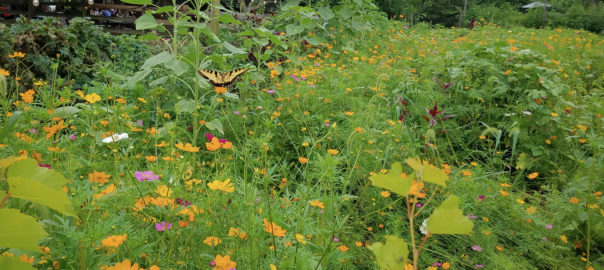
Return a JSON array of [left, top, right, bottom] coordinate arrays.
[[7, 176, 75, 216]]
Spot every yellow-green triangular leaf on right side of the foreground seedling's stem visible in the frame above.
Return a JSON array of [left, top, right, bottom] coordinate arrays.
[[426, 195, 474, 234]]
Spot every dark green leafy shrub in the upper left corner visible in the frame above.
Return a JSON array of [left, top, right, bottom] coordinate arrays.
[[0, 18, 149, 87]]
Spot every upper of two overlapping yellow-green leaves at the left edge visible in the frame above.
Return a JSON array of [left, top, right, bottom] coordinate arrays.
[[6, 159, 67, 193]]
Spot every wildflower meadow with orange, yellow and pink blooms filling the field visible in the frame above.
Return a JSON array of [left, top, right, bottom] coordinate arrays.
[[0, 2, 604, 270]]
